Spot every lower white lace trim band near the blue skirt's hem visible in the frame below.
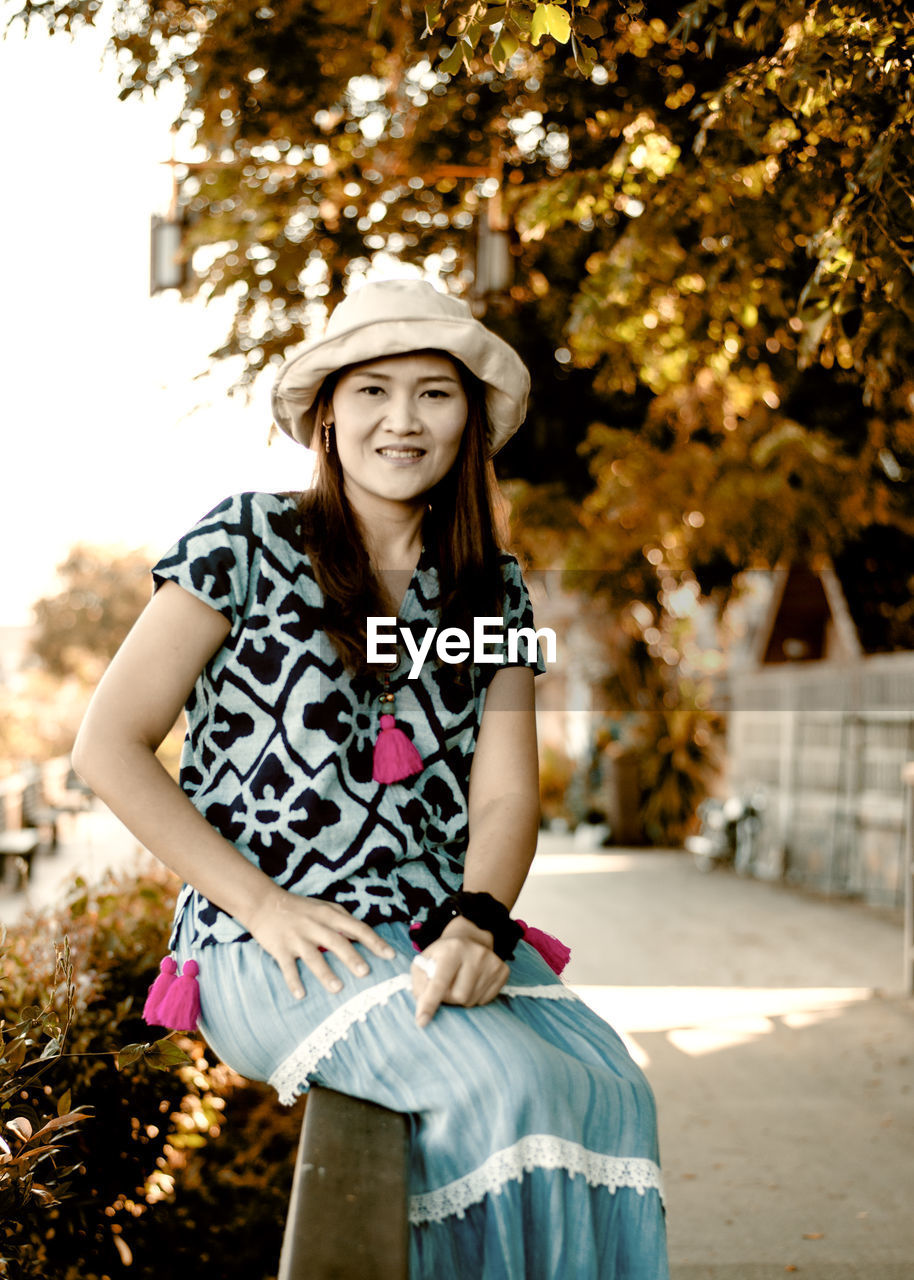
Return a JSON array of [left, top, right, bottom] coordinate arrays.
[[410, 1133, 663, 1226]]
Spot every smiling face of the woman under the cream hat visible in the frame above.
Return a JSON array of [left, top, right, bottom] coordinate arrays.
[[328, 352, 467, 508]]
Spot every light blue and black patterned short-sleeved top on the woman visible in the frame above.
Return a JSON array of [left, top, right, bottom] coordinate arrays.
[[152, 493, 545, 946]]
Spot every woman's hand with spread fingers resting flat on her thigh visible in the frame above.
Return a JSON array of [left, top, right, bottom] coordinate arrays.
[[243, 886, 397, 1000]]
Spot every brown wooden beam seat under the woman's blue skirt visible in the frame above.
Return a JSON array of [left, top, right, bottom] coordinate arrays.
[[278, 1085, 410, 1280]]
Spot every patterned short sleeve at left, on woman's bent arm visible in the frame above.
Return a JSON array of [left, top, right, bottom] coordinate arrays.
[[152, 493, 255, 623]]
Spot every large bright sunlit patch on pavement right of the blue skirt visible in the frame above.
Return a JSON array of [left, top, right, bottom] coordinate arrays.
[[572, 984, 873, 1068]]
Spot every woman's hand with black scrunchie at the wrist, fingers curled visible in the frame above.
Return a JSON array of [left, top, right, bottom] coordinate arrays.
[[412, 915, 511, 1027]]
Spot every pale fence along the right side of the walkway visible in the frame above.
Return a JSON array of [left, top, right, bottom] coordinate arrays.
[[728, 653, 914, 906]]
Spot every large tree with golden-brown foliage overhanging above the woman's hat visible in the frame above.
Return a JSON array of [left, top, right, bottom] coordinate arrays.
[[12, 0, 914, 834]]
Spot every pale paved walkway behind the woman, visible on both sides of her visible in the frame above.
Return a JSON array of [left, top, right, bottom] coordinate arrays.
[[0, 803, 914, 1280]]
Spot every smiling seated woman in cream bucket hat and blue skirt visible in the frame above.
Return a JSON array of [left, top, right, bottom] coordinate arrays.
[[74, 280, 667, 1280]]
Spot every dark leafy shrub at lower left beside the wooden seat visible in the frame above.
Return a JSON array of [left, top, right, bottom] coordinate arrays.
[[0, 874, 301, 1280]]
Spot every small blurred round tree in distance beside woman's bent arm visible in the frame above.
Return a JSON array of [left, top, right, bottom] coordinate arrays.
[[32, 544, 151, 684]]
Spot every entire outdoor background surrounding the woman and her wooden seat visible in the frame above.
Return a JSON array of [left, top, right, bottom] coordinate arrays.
[[0, 0, 914, 1280]]
